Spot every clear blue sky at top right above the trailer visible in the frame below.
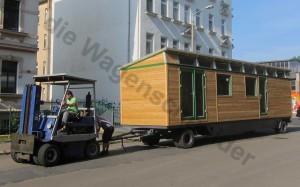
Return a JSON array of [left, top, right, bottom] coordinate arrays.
[[232, 0, 300, 62]]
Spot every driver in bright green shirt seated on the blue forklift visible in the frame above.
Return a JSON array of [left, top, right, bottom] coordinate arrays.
[[58, 90, 78, 132]]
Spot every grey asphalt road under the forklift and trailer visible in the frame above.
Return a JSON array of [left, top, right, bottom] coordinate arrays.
[[0, 118, 300, 187]]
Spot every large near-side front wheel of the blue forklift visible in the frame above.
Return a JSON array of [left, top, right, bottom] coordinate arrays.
[[38, 144, 60, 167]]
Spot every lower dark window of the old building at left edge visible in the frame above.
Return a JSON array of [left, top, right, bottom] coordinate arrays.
[[1, 61, 18, 93]]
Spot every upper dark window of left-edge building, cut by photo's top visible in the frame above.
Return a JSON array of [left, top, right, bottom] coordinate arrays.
[[3, 0, 20, 31]]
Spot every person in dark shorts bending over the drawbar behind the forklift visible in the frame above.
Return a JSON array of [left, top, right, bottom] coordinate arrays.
[[97, 116, 115, 155]]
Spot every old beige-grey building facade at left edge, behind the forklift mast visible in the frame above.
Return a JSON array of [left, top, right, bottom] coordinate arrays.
[[0, 0, 38, 115]]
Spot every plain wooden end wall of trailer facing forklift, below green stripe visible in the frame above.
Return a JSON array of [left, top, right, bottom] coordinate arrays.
[[120, 65, 167, 126]]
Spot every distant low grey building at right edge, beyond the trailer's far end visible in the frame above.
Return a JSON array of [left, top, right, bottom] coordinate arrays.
[[260, 59, 300, 112]]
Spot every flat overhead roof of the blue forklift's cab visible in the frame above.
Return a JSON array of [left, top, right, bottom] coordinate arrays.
[[33, 74, 96, 85]]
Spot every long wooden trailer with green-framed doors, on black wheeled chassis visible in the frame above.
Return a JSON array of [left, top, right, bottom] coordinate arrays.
[[120, 48, 292, 148]]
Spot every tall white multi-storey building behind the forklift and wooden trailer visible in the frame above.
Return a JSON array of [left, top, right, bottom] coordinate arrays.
[[47, 0, 232, 101]]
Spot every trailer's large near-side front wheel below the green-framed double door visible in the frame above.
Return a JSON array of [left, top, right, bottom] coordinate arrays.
[[173, 129, 195, 149]]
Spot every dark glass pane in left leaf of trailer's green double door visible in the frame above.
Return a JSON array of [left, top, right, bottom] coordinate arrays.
[[181, 71, 194, 117]]
